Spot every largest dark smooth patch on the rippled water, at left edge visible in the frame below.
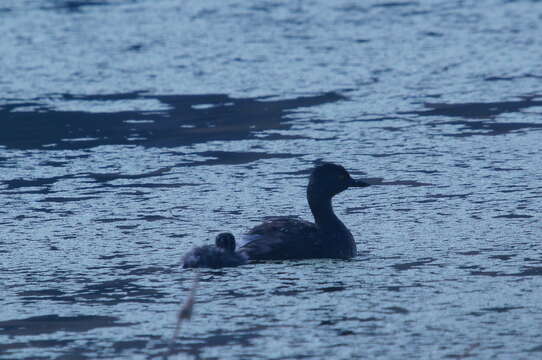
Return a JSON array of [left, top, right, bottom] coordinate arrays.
[[0, 92, 344, 150]]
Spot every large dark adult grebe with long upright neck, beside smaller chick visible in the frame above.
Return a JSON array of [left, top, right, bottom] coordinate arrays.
[[237, 163, 369, 260]]
